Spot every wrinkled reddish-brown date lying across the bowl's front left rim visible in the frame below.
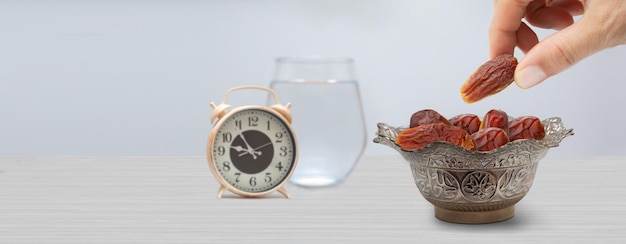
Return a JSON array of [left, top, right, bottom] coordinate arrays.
[[396, 123, 476, 150]]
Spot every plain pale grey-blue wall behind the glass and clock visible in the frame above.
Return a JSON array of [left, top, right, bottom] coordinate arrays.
[[0, 0, 626, 156]]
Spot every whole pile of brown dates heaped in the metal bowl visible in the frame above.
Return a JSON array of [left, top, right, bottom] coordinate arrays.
[[396, 109, 546, 152]]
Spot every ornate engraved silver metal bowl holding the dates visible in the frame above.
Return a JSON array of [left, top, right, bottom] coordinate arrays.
[[374, 117, 574, 223]]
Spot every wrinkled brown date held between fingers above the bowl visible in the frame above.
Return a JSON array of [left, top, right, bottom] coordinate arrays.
[[461, 54, 517, 103]]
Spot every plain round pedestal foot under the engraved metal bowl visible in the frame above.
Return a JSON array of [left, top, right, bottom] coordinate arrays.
[[435, 205, 515, 224]]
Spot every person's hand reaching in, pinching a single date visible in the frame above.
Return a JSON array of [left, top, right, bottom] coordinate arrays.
[[489, 0, 626, 88]]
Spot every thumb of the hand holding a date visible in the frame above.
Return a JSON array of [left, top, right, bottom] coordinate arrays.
[[515, 19, 606, 89]]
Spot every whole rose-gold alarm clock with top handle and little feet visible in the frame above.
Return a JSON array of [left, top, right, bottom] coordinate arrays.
[[206, 86, 298, 198]]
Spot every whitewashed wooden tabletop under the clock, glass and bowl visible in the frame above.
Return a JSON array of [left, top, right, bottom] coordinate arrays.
[[0, 155, 626, 243]]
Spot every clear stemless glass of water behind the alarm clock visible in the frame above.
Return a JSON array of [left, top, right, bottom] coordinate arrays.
[[268, 57, 366, 187]]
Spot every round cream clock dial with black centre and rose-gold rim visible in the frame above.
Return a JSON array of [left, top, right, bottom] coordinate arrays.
[[208, 108, 296, 193]]
